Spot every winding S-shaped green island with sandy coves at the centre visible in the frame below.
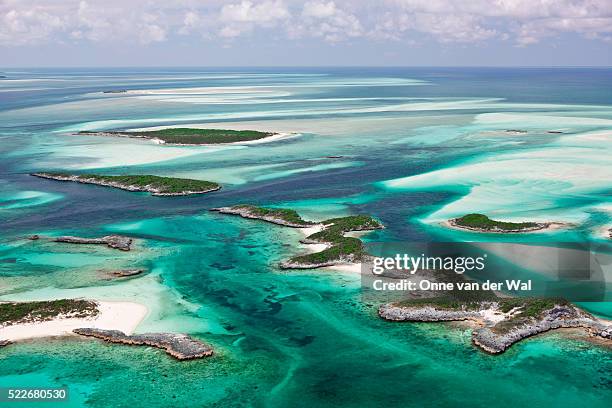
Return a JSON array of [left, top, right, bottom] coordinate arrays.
[[211, 204, 384, 269]]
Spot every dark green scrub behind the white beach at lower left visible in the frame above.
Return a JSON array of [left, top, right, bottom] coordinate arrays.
[[0, 299, 98, 326]]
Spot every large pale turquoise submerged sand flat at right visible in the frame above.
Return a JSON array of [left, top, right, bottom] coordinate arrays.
[[383, 124, 612, 233]]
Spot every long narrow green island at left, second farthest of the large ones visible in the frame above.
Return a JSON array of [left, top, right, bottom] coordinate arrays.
[[32, 173, 221, 196]]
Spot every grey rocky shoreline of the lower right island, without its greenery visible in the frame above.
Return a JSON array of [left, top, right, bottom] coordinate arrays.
[[378, 302, 612, 354]]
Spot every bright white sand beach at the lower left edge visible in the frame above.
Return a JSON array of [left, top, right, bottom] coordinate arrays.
[[0, 301, 148, 341]]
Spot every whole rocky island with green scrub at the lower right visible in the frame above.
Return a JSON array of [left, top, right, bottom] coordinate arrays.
[[378, 271, 612, 354]]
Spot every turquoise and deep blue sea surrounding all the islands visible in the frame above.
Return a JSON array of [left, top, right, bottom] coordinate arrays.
[[0, 69, 612, 407]]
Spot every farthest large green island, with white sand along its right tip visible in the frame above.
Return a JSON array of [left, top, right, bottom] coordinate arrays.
[[77, 128, 280, 145]]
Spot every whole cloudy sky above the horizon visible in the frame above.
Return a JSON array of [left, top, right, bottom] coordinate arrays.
[[0, 0, 612, 66]]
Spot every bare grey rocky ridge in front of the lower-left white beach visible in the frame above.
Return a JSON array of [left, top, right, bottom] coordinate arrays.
[[73, 328, 213, 360]]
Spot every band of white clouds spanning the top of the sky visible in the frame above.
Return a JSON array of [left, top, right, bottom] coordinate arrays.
[[0, 0, 612, 46]]
